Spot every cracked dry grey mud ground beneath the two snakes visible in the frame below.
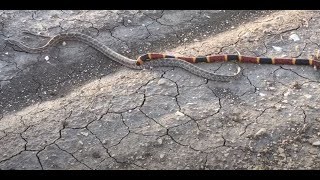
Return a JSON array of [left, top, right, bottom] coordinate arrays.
[[0, 10, 320, 170]]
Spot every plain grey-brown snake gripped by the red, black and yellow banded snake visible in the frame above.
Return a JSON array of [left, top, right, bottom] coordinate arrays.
[[6, 32, 241, 82]]
